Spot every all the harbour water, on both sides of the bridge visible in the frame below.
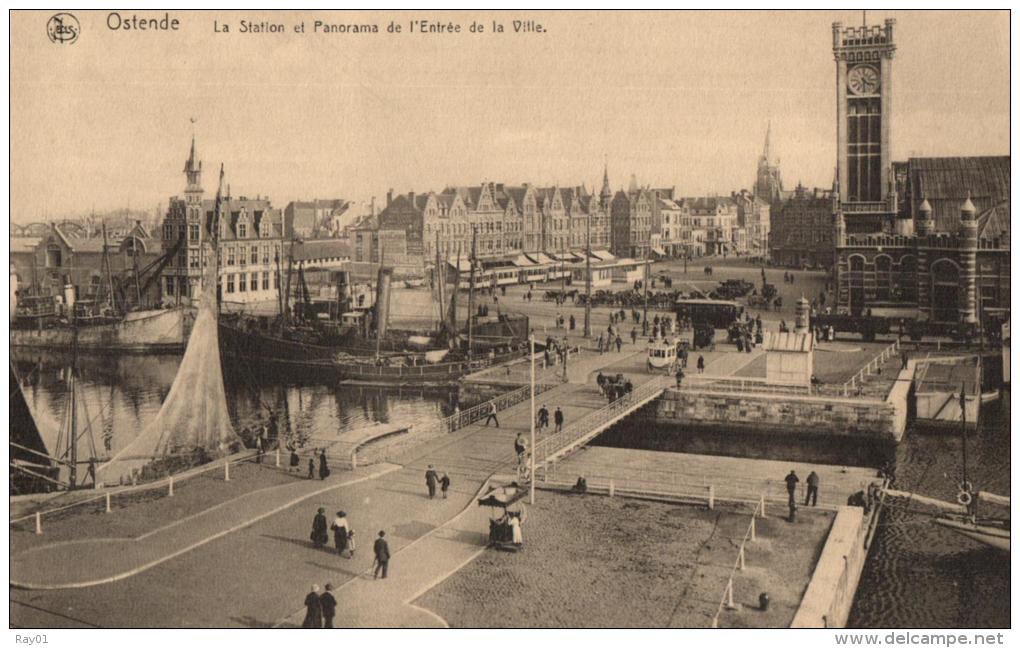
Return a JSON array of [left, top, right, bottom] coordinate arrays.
[[15, 351, 1010, 628]]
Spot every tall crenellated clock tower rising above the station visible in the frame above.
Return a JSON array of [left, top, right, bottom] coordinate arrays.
[[832, 18, 897, 234]]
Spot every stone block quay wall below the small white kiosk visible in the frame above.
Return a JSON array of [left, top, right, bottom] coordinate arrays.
[[646, 385, 909, 442]]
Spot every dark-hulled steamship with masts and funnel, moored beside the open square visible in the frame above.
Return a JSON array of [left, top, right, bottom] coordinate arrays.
[[219, 229, 529, 385]]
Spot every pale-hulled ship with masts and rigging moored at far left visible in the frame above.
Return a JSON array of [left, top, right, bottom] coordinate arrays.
[[10, 228, 191, 353]]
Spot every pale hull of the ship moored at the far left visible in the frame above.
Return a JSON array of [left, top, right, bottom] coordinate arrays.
[[10, 308, 189, 353]]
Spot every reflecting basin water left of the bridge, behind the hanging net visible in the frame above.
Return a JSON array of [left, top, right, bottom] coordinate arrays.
[[12, 350, 457, 456]]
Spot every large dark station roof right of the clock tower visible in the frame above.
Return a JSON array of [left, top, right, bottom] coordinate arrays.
[[908, 155, 1010, 232]]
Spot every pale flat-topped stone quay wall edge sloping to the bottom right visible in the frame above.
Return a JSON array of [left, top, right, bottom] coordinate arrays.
[[791, 506, 864, 628]]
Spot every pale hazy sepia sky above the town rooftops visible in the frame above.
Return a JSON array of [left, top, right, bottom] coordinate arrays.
[[10, 10, 1010, 222]]
